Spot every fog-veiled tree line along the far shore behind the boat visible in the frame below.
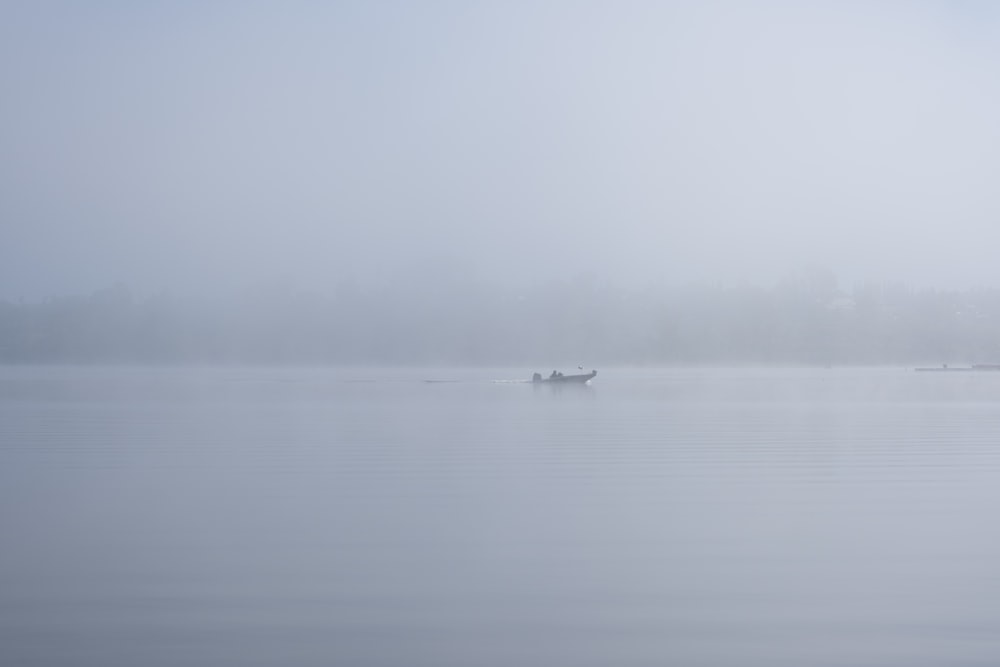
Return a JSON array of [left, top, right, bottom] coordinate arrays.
[[0, 272, 1000, 367]]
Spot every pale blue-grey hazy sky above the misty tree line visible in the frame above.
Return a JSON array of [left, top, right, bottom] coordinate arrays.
[[0, 1, 1000, 298]]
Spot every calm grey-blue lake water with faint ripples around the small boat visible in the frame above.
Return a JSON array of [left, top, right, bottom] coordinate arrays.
[[0, 368, 1000, 667]]
